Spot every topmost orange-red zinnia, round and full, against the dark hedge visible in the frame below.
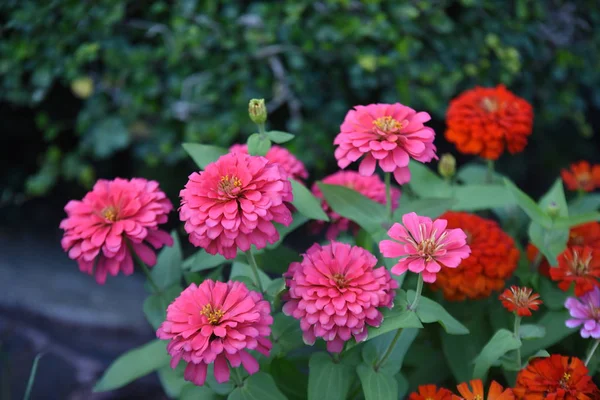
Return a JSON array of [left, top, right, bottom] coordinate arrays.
[[445, 85, 533, 160]]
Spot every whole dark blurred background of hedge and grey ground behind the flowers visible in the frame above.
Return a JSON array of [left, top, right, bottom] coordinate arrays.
[[0, 0, 600, 399]]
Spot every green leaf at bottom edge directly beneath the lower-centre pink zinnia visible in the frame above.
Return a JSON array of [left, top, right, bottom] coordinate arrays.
[[308, 353, 355, 400]]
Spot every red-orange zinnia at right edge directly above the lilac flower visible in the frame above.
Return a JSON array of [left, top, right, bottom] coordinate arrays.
[[550, 246, 600, 297]]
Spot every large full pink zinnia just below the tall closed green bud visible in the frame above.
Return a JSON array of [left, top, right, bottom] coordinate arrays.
[[179, 153, 292, 259]]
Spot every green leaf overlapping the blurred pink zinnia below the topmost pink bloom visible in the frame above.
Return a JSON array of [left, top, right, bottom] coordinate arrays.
[[317, 182, 388, 235]]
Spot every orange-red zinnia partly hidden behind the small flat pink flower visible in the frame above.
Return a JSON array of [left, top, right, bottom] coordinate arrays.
[[433, 212, 519, 301]]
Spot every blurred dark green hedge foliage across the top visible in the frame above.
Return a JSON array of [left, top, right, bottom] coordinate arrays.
[[0, 0, 600, 194]]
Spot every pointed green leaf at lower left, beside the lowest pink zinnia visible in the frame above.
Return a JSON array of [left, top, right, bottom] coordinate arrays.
[[94, 340, 171, 392]]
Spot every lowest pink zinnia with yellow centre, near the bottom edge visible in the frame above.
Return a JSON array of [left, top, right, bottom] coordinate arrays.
[[156, 279, 273, 386]]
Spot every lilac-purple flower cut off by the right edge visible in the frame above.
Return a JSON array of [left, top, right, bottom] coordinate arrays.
[[565, 287, 600, 339]]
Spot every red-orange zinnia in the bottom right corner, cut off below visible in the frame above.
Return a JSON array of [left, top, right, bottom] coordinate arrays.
[[513, 354, 600, 400]]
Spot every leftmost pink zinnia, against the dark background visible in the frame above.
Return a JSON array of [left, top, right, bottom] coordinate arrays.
[[60, 178, 173, 284]]
